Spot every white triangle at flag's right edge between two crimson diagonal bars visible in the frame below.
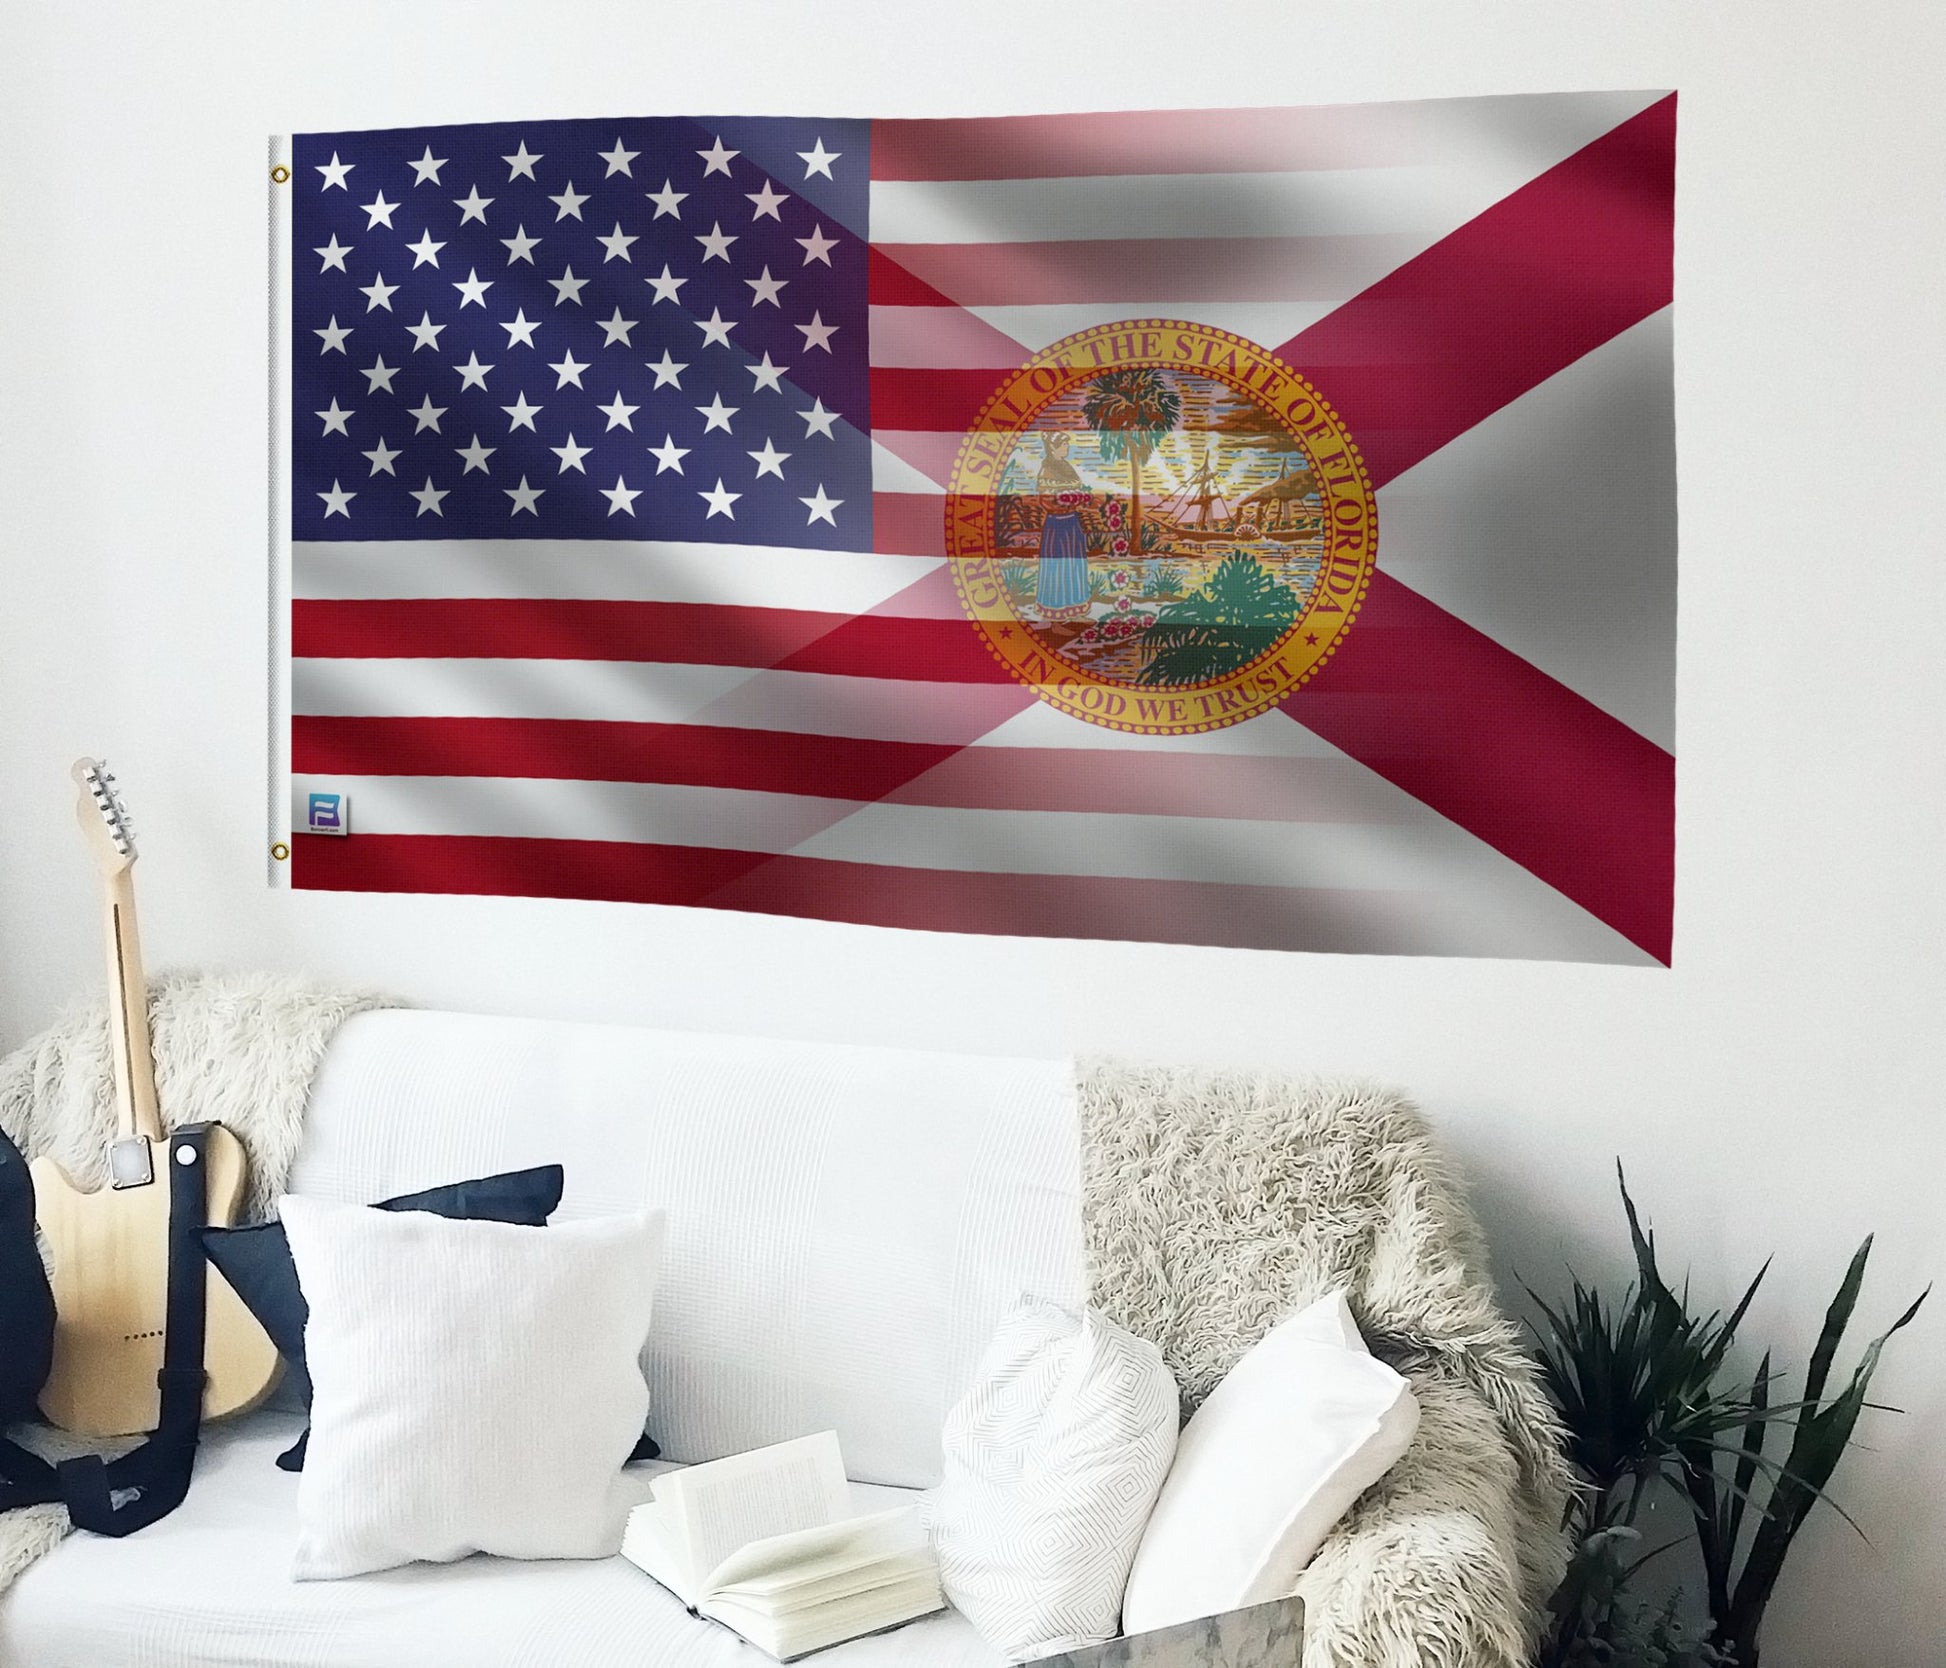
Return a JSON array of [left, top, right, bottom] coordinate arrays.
[[1352, 309, 1676, 751]]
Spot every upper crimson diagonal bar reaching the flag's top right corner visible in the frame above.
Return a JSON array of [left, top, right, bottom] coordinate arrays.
[[1277, 93, 1676, 487]]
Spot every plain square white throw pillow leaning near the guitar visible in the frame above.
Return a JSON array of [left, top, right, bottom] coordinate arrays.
[[280, 1197, 664, 1580]]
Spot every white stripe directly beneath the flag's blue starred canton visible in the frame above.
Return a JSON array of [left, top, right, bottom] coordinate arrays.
[[294, 539, 944, 613]]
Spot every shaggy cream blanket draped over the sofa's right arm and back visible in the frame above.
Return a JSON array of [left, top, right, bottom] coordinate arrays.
[[1078, 1061, 1572, 1668]]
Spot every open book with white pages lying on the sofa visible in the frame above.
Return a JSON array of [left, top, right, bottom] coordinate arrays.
[[621, 1431, 946, 1662]]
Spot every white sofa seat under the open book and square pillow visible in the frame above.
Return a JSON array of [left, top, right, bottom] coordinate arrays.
[[0, 1409, 1000, 1668]]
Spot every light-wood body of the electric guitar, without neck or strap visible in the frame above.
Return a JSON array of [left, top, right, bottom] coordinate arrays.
[[31, 1125, 282, 1436]]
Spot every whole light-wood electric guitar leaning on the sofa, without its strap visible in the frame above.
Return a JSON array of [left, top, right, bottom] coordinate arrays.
[[31, 759, 280, 1436]]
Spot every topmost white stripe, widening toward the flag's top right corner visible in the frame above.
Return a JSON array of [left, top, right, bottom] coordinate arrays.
[[872, 91, 1660, 243]]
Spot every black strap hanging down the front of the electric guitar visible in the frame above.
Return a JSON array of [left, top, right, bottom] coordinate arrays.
[[56, 1123, 210, 1536]]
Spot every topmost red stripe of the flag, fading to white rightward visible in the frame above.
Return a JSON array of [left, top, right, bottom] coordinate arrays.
[[872, 103, 1436, 179]]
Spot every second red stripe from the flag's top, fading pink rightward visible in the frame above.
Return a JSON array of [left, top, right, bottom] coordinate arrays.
[[872, 234, 1419, 309]]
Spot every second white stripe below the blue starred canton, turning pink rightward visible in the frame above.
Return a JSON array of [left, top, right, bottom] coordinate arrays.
[[292, 657, 1019, 742]]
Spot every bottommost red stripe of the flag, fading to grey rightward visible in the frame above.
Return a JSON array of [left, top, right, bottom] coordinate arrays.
[[290, 833, 1440, 954]]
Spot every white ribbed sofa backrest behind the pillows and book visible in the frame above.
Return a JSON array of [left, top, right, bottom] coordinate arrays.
[[290, 1012, 1084, 1487]]
